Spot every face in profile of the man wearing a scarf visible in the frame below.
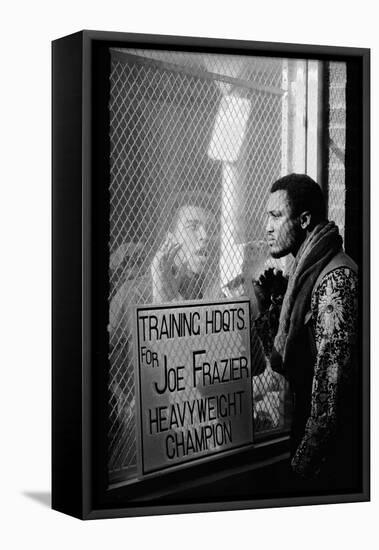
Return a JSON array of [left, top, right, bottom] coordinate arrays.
[[266, 190, 302, 258]]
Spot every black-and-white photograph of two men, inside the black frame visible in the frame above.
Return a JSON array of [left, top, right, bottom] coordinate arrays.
[[108, 49, 362, 498]]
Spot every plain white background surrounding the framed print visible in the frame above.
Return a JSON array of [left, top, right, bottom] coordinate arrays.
[[0, 0, 379, 550]]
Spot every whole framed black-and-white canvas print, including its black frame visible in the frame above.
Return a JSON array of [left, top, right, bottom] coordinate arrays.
[[52, 31, 369, 519]]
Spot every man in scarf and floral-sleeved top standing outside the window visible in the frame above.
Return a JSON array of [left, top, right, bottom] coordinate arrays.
[[256, 174, 359, 489]]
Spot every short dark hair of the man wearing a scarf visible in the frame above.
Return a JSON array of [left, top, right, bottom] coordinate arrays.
[[270, 174, 326, 223]]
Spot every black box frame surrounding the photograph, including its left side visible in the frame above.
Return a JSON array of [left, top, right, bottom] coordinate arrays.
[[52, 31, 370, 519]]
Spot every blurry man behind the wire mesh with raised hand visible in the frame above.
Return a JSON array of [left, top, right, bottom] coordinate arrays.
[[109, 200, 220, 448]]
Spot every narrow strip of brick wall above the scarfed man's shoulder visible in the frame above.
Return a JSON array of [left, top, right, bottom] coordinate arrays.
[[328, 62, 346, 242]]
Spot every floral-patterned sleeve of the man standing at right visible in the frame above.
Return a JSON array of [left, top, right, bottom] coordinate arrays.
[[292, 267, 358, 477]]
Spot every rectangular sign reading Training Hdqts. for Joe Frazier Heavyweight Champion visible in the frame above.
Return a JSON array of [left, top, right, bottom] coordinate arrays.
[[137, 301, 253, 473]]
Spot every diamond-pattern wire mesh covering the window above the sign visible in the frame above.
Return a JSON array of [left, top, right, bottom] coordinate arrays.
[[108, 50, 290, 479]]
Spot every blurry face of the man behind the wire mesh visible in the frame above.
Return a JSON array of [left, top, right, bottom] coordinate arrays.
[[174, 206, 208, 273]]
